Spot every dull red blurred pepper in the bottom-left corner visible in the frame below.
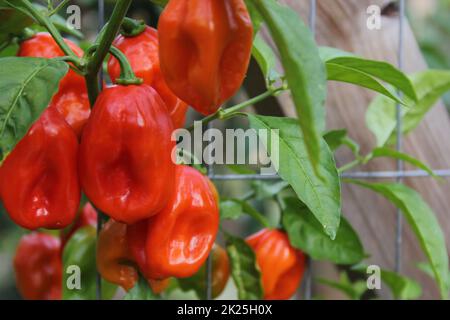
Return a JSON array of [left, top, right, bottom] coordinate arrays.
[[14, 232, 63, 300]]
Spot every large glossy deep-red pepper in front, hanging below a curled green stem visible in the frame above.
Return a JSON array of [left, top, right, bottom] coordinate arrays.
[[79, 85, 175, 224]]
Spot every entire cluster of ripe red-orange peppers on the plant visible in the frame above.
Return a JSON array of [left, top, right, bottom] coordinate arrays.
[[4, 0, 305, 299]]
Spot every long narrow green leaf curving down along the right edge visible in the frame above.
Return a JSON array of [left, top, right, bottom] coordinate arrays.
[[347, 180, 448, 299]]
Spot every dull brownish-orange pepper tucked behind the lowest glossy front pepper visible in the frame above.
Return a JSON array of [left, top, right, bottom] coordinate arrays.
[[97, 219, 170, 293]]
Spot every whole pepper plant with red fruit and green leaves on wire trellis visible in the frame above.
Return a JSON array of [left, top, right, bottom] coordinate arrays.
[[0, 0, 450, 299]]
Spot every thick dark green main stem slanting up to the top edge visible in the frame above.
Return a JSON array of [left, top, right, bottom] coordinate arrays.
[[87, 0, 132, 75]]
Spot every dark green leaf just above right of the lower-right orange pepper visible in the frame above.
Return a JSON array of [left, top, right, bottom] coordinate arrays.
[[282, 198, 366, 264]]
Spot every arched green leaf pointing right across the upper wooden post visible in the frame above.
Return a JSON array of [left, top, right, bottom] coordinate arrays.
[[319, 47, 417, 103]]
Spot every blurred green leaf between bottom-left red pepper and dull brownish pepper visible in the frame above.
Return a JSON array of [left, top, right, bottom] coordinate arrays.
[[63, 226, 97, 300]]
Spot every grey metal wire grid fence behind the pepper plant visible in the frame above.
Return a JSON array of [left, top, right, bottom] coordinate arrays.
[[94, 0, 442, 300]]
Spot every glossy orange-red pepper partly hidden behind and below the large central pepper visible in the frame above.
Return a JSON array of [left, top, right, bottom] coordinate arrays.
[[127, 165, 219, 279]]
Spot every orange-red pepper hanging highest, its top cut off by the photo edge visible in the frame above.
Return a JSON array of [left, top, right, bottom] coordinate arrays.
[[158, 0, 253, 115]]
